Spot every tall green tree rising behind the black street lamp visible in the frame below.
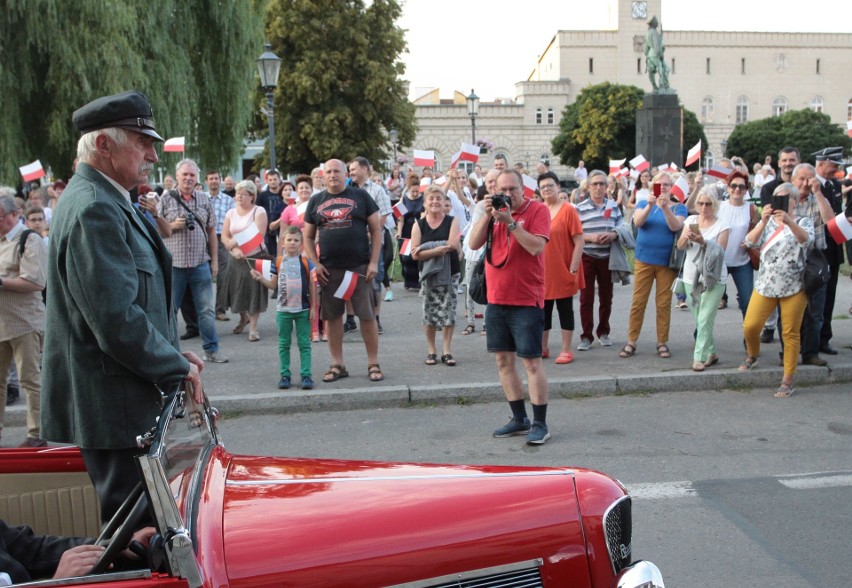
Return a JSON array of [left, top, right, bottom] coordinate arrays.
[[256, 0, 416, 172]]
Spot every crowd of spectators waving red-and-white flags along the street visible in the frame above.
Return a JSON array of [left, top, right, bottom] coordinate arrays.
[[0, 90, 852, 446]]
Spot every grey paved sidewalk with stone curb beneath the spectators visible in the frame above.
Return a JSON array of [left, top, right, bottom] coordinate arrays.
[[6, 276, 852, 426]]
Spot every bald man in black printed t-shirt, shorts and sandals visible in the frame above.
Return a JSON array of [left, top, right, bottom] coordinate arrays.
[[305, 159, 384, 382]]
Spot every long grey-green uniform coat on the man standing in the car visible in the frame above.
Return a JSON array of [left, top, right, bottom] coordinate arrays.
[[41, 163, 189, 449]]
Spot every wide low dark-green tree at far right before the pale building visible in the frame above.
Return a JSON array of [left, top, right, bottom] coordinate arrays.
[[727, 109, 852, 163]]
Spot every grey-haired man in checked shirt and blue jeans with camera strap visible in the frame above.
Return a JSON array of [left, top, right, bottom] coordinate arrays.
[[159, 159, 228, 363]]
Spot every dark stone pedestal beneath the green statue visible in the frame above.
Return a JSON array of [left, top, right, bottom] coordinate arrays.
[[636, 94, 683, 166]]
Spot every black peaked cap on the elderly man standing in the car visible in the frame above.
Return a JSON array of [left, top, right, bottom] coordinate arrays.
[[72, 90, 163, 141]]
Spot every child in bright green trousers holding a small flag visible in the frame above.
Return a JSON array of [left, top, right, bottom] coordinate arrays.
[[251, 225, 317, 390]]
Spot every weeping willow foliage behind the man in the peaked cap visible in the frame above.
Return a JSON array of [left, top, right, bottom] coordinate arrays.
[[0, 0, 262, 185]]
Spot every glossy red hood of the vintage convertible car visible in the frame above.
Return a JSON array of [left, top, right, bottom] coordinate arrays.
[[212, 456, 589, 586]]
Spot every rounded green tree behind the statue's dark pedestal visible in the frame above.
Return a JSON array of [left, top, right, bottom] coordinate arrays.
[[552, 82, 707, 170]]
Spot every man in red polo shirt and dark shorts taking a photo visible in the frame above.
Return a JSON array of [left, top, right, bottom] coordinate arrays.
[[467, 170, 550, 445]]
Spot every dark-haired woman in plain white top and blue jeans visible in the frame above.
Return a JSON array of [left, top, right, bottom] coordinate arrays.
[[718, 169, 760, 318]]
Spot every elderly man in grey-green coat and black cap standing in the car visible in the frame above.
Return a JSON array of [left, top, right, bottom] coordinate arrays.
[[41, 91, 203, 521]]
